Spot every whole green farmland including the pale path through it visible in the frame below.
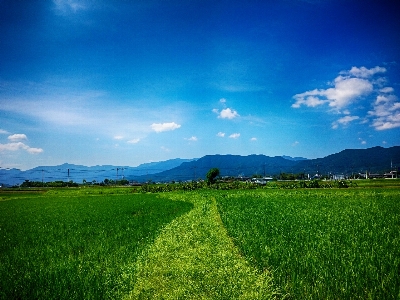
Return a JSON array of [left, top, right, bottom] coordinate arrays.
[[0, 181, 400, 299]]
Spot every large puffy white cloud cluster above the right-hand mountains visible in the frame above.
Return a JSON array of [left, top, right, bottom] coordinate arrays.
[[292, 66, 400, 130]]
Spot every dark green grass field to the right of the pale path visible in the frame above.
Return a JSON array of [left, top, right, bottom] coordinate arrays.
[[217, 189, 400, 299]]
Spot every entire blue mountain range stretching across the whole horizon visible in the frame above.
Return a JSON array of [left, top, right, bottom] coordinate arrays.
[[0, 146, 400, 185]]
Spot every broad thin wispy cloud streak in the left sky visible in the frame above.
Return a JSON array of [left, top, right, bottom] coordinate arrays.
[[0, 79, 186, 136]]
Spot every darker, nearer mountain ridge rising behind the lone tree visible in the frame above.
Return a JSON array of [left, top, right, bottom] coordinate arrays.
[[131, 146, 400, 182]]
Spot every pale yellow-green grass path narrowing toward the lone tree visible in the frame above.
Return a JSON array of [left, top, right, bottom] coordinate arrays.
[[127, 192, 277, 299]]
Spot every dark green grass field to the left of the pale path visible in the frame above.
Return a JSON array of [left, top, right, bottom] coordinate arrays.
[[0, 189, 193, 299]]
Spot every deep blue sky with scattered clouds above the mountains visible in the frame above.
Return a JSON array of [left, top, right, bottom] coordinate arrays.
[[0, 0, 400, 170]]
